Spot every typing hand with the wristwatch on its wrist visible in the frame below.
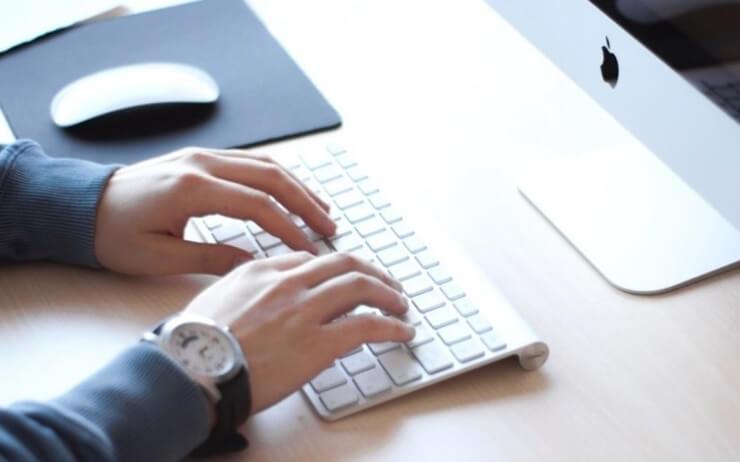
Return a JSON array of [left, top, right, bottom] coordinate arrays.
[[186, 252, 414, 412]]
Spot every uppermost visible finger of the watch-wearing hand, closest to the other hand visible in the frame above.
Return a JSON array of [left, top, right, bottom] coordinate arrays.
[[292, 252, 403, 292]]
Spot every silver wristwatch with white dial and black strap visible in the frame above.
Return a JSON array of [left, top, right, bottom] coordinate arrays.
[[142, 313, 252, 456]]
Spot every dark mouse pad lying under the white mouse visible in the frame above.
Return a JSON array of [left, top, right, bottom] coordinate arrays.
[[0, 0, 341, 163]]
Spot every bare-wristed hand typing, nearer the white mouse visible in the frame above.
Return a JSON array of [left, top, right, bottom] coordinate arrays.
[[95, 148, 336, 274]]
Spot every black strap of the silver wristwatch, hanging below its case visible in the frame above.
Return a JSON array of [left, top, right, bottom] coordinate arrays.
[[192, 367, 252, 457]]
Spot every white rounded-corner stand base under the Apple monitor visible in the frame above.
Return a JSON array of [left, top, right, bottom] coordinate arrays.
[[519, 143, 740, 294]]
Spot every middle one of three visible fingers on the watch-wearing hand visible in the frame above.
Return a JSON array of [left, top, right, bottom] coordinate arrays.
[[306, 272, 409, 323]]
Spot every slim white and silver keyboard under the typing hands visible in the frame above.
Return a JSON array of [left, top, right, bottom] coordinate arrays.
[[194, 145, 548, 420]]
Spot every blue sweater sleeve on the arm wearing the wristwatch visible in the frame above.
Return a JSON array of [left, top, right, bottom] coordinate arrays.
[[0, 343, 209, 462]]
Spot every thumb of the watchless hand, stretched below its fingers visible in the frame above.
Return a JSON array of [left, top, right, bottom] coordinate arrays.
[[146, 235, 253, 275]]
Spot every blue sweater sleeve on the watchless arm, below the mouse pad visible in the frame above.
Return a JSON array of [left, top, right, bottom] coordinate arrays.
[[0, 140, 117, 267]]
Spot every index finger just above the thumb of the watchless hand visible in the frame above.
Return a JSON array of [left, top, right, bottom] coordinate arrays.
[[190, 177, 318, 254]]
